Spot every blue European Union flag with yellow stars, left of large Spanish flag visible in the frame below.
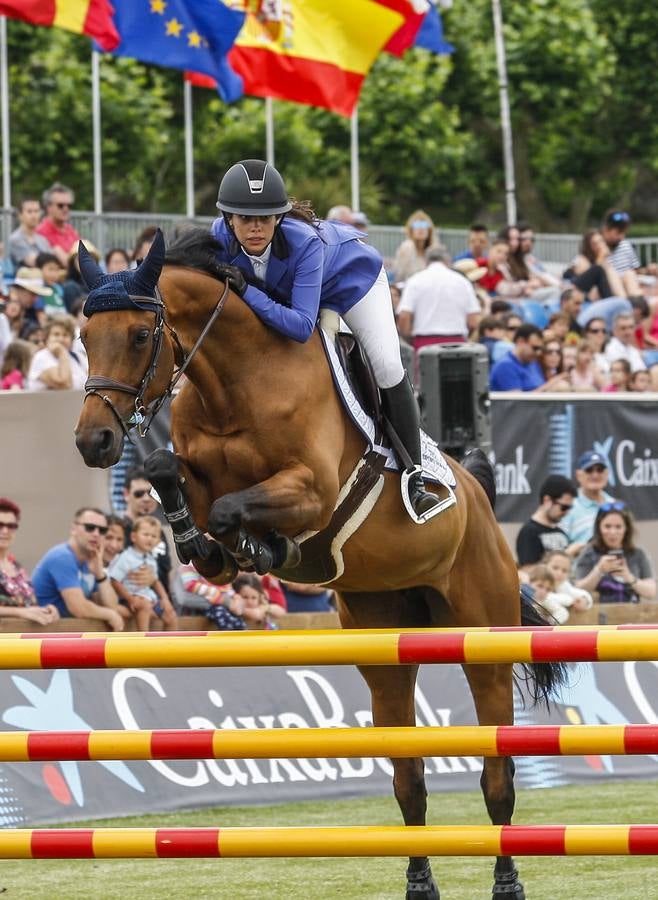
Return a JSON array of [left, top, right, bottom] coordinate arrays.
[[105, 0, 245, 101]]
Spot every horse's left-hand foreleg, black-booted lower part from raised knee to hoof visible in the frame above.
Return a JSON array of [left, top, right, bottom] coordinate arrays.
[[144, 449, 237, 583]]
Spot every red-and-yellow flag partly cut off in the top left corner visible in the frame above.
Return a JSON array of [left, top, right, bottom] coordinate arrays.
[[0, 0, 119, 50]]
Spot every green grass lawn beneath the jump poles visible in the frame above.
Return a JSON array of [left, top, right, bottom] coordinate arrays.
[[0, 782, 658, 900]]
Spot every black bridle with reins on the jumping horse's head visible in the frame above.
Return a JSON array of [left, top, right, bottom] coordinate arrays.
[[85, 281, 229, 444]]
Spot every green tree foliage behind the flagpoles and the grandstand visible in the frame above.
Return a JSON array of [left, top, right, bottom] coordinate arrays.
[[2, 0, 658, 229]]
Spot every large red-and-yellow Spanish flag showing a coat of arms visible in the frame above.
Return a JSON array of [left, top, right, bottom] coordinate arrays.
[[226, 0, 413, 116]]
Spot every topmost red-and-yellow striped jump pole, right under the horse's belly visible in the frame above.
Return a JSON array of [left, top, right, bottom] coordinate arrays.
[[0, 626, 658, 669]]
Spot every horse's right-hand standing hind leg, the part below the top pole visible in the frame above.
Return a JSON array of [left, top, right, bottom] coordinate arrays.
[[464, 665, 525, 900]]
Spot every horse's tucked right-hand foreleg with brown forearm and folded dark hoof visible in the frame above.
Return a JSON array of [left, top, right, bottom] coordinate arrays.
[[208, 465, 322, 574]]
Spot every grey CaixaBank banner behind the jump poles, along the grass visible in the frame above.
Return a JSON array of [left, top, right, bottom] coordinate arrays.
[[0, 662, 658, 827]]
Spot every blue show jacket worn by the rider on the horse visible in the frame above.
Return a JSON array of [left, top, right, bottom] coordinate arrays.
[[211, 217, 382, 343]]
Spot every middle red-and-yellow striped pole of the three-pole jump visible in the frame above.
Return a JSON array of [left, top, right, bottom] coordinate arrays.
[[0, 725, 658, 762]]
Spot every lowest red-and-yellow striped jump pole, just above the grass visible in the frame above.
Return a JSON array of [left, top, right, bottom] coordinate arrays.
[[0, 825, 658, 859]]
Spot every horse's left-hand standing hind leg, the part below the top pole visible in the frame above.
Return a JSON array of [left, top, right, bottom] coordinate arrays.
[[359, 660, 439, 900]]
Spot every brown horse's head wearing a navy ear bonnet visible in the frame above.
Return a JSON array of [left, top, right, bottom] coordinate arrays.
[[75, 231, 174, 468]]
